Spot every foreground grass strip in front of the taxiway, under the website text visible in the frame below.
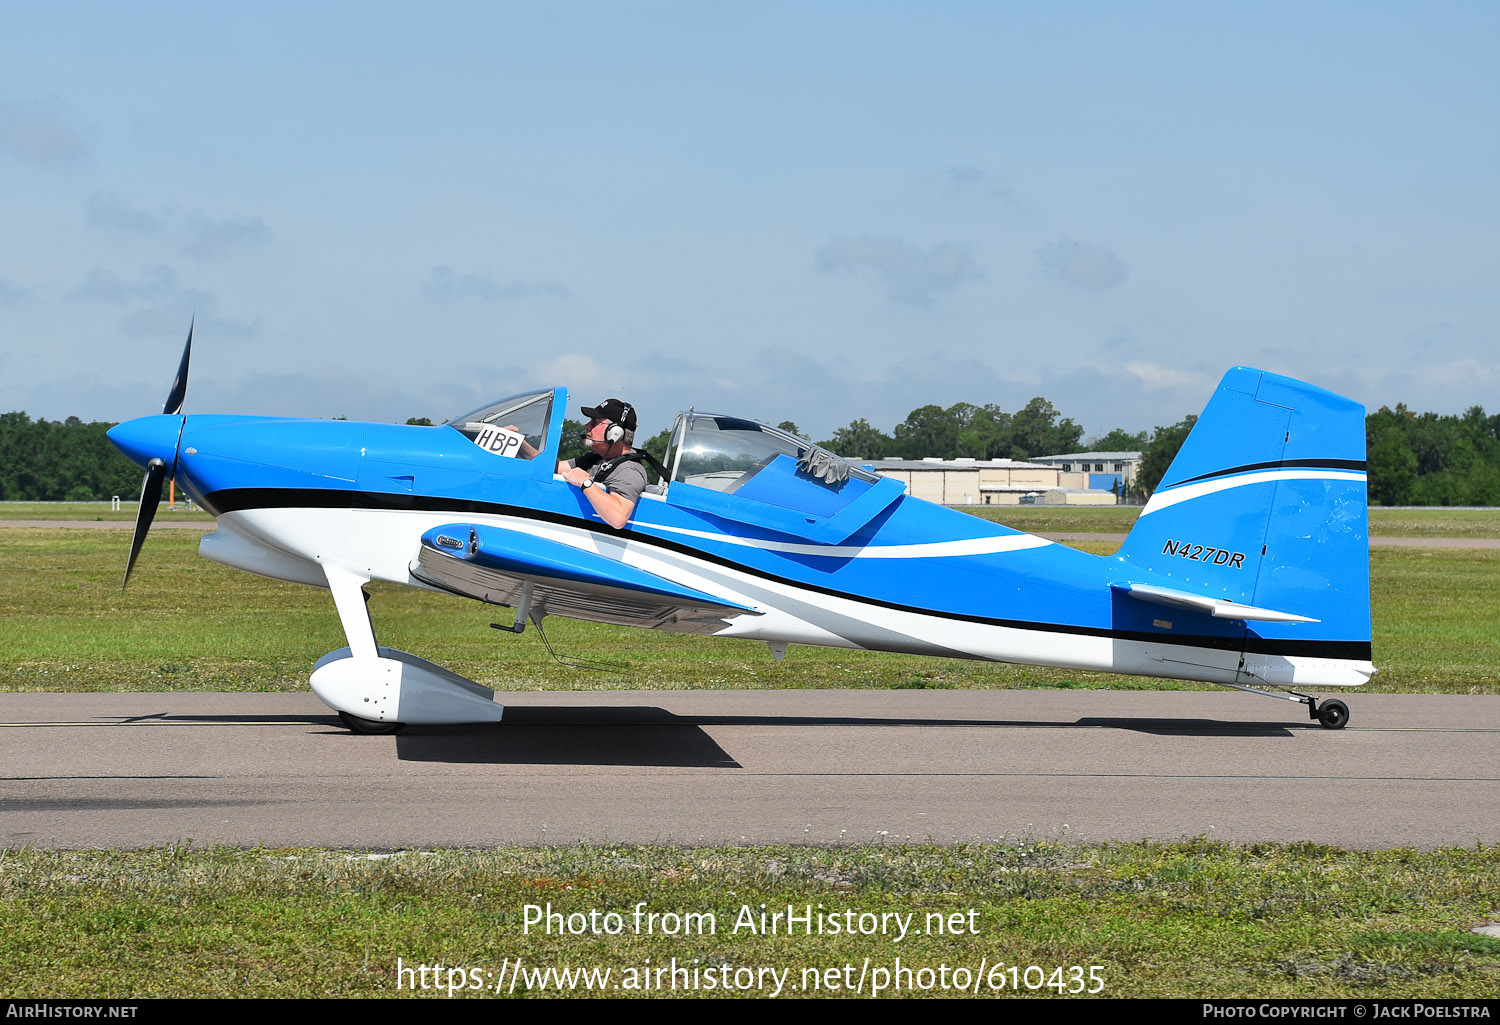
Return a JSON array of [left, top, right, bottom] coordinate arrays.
[[0, 840, 1500, 999]]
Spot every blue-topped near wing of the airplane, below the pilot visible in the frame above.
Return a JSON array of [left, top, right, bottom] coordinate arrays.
[[411, 524, 761, 633]]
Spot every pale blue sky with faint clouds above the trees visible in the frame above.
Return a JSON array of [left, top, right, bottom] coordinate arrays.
[[0, 0, 1500, 438]]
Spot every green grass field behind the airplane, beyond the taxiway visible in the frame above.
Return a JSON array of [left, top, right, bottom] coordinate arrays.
[[0, 527, 1500, 693]]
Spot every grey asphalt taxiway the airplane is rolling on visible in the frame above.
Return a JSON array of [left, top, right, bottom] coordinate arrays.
[[0, 690, 1500, 849]]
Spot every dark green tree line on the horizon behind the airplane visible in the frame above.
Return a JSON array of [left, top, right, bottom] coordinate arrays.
[[0, 396, 1500, 506]]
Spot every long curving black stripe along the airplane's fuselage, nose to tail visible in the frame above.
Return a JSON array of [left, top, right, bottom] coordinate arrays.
[[200, 488, 1371, 662]]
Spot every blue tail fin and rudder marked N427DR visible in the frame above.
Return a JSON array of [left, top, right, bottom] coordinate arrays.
[[1116, 368, 1373, 684]]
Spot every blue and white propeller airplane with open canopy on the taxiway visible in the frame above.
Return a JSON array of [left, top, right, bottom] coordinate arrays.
[[110, 330, 1376, 732]]
